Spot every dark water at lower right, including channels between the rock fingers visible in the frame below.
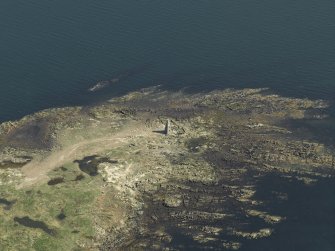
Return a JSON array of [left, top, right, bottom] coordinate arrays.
[[147, 173, 335, 251]]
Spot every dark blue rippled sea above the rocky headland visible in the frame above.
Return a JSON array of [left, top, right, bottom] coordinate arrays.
[[0, 0, 335, 121]]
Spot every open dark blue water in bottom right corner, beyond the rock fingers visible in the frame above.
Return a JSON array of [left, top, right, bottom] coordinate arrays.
[[241, 175, 335, 251]]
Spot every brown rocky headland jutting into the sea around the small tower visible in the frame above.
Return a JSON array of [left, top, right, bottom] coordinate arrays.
[[0, 88, 335, 250]]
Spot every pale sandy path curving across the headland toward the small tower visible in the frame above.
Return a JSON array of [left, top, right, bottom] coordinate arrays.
[[19, 123, 151, 188]]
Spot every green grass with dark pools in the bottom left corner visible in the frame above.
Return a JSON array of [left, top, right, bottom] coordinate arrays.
[[0, 164, 102, 251]]
